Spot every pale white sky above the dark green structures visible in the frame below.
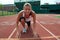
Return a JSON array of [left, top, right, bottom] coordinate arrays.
[[0, 0, 60, 4]]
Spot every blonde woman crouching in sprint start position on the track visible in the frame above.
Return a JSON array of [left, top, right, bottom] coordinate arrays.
[[16, 3, 36, 33]]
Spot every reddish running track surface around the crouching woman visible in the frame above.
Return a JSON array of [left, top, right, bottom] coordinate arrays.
[[0, 14, 60, 40]]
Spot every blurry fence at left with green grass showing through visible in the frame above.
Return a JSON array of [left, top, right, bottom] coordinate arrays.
[[0, 5, 17, 16]]
